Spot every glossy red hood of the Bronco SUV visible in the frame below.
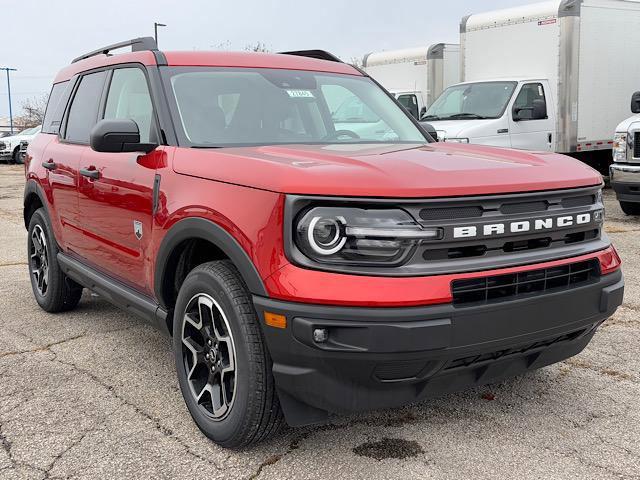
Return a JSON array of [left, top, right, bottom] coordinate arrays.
[[174, 143, 602, 198]]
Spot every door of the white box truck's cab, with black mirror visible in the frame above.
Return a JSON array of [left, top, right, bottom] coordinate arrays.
[[509, 82, 555, 151]]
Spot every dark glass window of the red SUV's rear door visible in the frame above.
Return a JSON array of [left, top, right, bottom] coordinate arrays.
[[64, 72, 106, 143]]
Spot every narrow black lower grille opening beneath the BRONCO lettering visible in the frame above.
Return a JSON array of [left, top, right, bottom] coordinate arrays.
[[451, 260, 600, 305]]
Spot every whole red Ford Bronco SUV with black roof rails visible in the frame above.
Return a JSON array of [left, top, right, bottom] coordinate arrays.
[[24, 38, 623, 447]]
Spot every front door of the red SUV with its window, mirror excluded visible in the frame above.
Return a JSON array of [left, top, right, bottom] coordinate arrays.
[[78, 67, 161, 293]]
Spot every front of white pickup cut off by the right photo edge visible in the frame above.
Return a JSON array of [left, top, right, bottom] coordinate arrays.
[[611, 92, 640, 215]]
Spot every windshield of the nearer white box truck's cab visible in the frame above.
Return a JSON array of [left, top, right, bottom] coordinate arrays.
[[421, 82, 517, 120]]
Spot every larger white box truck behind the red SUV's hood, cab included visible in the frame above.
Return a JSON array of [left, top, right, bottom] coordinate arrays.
[[422, 0, 640, 174]]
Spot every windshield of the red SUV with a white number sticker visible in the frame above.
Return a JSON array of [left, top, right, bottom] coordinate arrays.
[[163, 67, 428, 147]]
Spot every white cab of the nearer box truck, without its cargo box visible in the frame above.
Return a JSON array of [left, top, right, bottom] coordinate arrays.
[[421, 78, 556, 151]]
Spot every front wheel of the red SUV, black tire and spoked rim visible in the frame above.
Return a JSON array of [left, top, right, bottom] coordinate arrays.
[[173, 260, 284, 448]]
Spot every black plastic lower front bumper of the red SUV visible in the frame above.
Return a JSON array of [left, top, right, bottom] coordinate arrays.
[[254, 270, 624, 426]]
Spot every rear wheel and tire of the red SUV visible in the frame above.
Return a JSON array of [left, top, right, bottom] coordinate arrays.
[[27, 208, 82, 313]]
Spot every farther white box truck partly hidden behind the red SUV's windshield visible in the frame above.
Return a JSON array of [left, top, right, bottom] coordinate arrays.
[[362, 43, 460, 118]]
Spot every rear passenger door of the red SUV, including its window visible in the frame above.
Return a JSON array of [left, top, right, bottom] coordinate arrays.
[[50, 72, 106, 250]]
